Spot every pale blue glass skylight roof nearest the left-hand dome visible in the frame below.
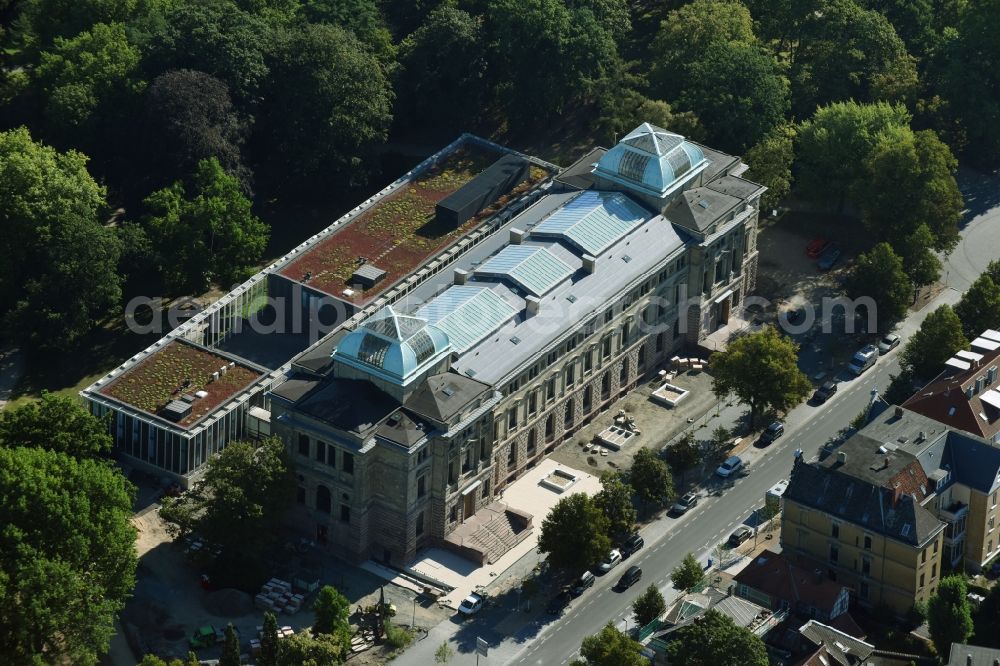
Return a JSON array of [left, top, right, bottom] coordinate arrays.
[[417, 285, 517, 353]]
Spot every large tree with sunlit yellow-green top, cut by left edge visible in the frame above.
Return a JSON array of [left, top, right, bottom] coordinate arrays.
[[0, 127, 121, 350]]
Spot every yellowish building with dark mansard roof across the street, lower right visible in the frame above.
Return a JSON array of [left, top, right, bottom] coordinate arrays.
[[781, 407, 1000, 613]]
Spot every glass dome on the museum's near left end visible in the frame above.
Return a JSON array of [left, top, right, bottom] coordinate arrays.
[[333, 305, 451, 383]]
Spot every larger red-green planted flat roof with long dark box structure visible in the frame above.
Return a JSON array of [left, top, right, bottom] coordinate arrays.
[[278, 141, 550, 307]]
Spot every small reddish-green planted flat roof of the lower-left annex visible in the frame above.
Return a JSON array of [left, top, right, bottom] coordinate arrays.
[[98, 339, 264, 428]]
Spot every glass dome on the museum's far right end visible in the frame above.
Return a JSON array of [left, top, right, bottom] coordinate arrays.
[[594, 123, 708, 197]]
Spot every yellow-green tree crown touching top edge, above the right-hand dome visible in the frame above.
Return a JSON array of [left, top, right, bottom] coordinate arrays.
[[649, 0, 756, 99]]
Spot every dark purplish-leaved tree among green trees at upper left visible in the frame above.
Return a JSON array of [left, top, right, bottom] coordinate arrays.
[[139, 69, 251, 189]]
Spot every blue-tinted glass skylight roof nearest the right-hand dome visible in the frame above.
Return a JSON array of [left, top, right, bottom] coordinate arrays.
[[531, 190, 652, 257]]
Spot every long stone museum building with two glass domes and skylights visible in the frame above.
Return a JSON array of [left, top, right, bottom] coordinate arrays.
[[271, 125, 764, 564]]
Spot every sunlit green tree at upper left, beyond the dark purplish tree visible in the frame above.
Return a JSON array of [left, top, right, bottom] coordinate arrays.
[[35, 23, 143, 134]]
